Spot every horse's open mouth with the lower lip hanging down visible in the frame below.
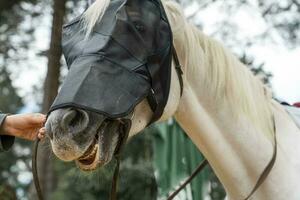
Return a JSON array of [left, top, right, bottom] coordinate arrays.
[[75, 121, 126, 171]]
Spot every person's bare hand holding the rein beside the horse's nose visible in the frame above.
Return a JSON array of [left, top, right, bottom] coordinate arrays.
[[1, 113, 46, 140]]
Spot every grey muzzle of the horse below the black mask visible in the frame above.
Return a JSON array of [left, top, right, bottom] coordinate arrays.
[[46, 108, 130, 171]]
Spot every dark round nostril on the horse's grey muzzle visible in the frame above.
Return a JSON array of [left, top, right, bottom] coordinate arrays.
[[61, 109, 89, 132]]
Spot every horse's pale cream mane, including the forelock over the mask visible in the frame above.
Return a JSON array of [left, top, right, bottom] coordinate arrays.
[[82, 0, 273, 138]]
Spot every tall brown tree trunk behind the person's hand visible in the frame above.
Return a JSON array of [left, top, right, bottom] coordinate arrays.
[[31, 0, 66, 200]]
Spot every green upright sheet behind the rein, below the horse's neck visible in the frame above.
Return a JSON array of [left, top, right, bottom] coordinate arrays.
[[153, 120, 210, 200]]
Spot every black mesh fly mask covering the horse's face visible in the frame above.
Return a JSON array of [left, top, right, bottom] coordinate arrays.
[[50, 0, 181, 122]]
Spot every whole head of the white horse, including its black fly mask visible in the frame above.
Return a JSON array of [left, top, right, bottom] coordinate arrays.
[[46, 0, 179, 170]]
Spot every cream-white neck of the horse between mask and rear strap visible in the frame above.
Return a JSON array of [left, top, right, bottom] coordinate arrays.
[[175, 25, 272, 199]]
